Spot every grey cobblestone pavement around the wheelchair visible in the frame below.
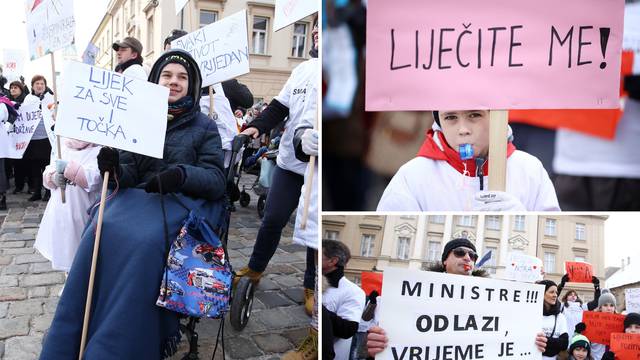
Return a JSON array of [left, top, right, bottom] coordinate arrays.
[[0, 174, 310, 360]]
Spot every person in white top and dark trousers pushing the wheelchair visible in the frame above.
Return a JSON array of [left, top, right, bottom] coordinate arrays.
[[234, 17, 320, 315]]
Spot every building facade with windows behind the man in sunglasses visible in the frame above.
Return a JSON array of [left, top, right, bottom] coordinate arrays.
[[322, 215, 607, 300]]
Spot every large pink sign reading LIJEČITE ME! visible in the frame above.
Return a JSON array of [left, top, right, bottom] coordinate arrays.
[[366, 0, 624, 111]]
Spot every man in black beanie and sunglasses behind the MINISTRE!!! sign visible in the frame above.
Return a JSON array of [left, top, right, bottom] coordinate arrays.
[[367, 238, 547, 357]]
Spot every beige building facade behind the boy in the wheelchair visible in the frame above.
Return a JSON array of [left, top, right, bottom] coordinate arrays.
[[86, 0, 313, 103]]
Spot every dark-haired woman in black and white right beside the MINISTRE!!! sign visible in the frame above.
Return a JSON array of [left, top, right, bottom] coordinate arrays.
[[536, 280, 569, 360]]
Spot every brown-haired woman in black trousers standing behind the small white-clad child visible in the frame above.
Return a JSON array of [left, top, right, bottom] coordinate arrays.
[[22, 75, 54, 201]]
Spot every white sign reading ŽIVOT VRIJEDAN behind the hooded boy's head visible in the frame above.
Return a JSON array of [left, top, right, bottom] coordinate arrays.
[[171, 10, 249, 87]]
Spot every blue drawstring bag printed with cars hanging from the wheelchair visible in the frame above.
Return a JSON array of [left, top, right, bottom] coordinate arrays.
[[156, 211, 233, 318]]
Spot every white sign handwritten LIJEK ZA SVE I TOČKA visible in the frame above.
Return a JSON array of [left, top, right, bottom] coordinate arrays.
[[56, 61, 169, 158]]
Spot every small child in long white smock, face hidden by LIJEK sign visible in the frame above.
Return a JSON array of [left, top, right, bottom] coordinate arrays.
[[34, 139, 102, 271]]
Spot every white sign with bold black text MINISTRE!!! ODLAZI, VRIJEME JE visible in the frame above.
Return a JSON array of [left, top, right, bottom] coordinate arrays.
[[376, 268, 544, 360]]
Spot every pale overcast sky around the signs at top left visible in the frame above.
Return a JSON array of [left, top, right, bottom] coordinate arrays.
[[0, 0, 109, 82]]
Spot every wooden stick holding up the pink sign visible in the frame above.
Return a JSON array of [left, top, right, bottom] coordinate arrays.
[[489, 110, 509, 191]]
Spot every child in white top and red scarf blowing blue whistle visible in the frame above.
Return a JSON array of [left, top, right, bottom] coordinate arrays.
[[377, 110, 560, 211]]
